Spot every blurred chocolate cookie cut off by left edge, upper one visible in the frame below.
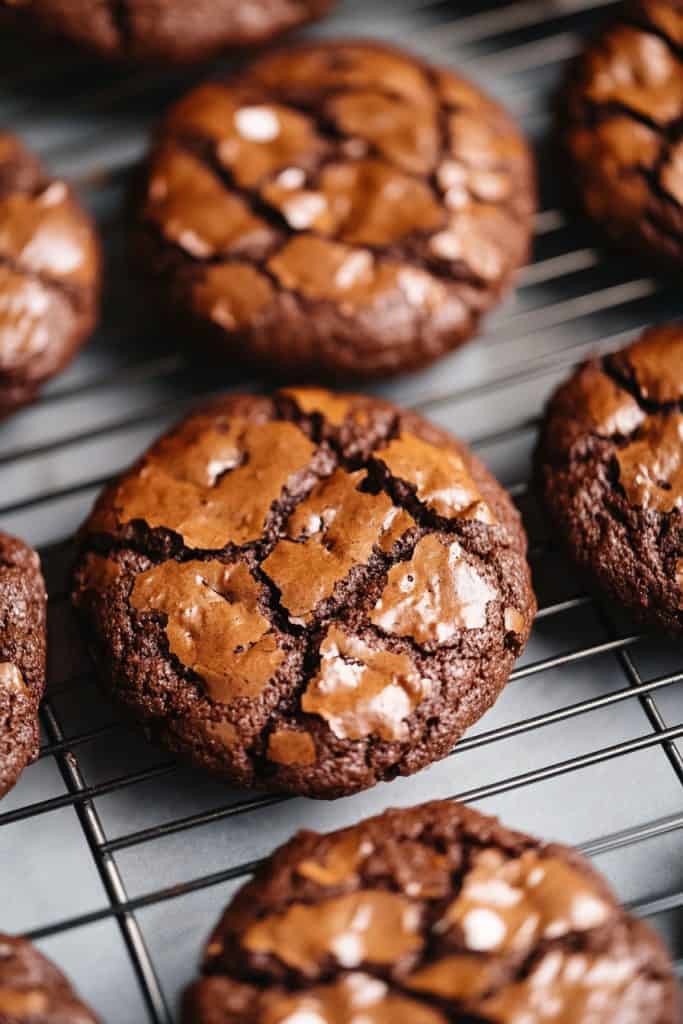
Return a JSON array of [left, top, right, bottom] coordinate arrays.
[[0, 132, 99, 417]]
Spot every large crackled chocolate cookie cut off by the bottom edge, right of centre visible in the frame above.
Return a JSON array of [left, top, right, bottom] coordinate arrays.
[[183, 802, 678, 1024]]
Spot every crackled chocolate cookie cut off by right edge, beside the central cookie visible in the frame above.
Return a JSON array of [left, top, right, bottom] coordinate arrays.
[[539, 325, 683, 632]]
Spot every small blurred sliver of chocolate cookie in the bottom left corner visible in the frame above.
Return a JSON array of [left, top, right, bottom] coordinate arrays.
[[0, 934, 97, 1024]]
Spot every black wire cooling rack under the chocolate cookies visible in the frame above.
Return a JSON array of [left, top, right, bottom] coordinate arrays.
[[0, 0, 683, 1024]]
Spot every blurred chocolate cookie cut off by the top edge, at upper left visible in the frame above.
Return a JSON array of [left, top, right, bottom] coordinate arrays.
[[0, 0, 333, 63]]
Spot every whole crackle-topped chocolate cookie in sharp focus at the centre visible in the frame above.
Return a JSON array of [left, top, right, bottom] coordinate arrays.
[[75, 390, 535, 797]]
